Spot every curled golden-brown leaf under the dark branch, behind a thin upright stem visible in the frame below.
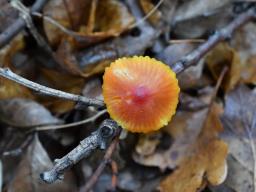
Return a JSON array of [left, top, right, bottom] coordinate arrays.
[[206, 43, 242, 92]]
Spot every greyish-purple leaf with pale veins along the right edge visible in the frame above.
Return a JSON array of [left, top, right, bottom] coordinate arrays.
[[218, 85, 256, 192]]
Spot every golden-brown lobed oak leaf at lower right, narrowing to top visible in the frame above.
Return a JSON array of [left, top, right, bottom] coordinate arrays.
[[160, 104, 228, 192]]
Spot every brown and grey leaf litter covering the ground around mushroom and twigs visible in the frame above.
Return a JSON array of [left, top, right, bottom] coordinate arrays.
[[0, 0, 256, 192]]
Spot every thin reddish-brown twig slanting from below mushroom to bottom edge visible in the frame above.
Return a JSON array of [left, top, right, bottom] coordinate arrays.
[[80, 133, 120, 192]]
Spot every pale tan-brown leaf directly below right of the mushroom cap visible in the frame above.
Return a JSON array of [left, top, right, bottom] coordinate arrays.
[[133, 86, 213, 170]]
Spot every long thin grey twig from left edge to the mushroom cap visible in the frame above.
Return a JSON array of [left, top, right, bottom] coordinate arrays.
[[0, 68, 104, 107]]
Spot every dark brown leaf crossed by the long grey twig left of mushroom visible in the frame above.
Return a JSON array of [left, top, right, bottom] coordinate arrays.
[[39, 69, 85, 113]]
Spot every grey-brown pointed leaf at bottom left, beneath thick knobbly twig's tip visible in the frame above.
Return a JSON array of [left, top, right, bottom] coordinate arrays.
[[7, 135, 77, 192]]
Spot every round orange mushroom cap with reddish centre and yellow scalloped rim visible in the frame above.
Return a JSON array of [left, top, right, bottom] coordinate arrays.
[[103, 56, 180, 133]]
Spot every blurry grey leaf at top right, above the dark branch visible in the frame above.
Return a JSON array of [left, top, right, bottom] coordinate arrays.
[[173, 0, 233, 39]]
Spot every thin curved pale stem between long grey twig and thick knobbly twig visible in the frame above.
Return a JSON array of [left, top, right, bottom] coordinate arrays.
[[35, 109, 107, 131]]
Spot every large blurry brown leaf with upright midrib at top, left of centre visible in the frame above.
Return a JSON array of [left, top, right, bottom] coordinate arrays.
[[44, 0, 134, 47]]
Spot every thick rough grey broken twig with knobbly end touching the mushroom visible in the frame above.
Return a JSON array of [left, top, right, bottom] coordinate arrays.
[[40, 119, 120, 183]]
